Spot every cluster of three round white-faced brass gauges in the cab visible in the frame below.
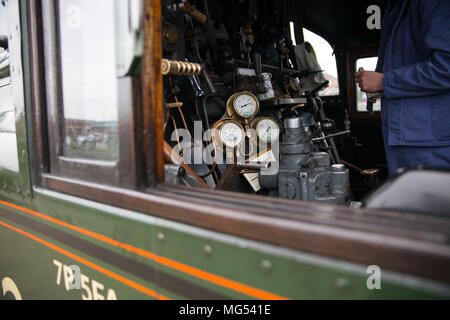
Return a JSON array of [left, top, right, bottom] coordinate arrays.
[[213, 91, 280, 149]]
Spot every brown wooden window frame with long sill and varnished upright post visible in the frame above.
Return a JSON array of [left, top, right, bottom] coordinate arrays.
[[23, 0, 450, 283]]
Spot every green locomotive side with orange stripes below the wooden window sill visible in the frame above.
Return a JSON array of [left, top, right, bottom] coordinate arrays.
[[0, 190, 448, 299]]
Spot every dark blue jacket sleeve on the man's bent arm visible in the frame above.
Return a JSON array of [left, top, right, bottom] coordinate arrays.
[[383, 0, 450, 99]]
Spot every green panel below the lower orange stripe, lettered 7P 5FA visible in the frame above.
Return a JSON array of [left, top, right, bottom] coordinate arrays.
[[0, 220, 149, 300]]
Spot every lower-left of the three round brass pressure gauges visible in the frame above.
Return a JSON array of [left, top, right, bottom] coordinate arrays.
[[212, 120, 245, 149]]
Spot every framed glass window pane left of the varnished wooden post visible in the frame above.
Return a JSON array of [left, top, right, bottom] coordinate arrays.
[[42, 0, 138, 188]]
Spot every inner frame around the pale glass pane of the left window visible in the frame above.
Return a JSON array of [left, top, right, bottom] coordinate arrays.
[[37, 0, 140, 189]]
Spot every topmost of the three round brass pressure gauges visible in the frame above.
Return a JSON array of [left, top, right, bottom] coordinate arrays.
[[227, 91, 259, 121]]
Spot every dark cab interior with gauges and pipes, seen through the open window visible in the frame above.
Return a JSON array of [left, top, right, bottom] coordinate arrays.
[[155, 0, 387, 205]]
